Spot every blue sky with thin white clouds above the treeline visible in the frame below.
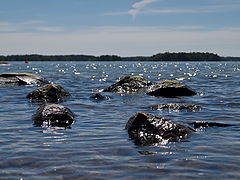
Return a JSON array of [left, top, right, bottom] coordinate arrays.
[[0, 0, 240, 57]]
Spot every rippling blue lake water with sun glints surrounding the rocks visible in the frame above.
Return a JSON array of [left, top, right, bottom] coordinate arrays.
[[0, 62, 240, 180]]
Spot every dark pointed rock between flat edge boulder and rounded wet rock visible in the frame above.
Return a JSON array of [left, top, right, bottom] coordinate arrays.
[[27, 84, 71, 103]]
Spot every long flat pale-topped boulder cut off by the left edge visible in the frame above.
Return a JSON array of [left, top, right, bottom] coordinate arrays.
[[0, 73, 49, 86]]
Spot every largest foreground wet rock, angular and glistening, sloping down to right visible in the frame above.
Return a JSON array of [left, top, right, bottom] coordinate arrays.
[[125, 112, 194, 145]]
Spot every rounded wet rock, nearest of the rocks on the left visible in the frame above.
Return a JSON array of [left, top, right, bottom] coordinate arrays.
[[33, 104, 75, 128]]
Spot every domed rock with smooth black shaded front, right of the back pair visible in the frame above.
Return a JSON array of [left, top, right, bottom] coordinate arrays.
[[147, 80, 196, 97]]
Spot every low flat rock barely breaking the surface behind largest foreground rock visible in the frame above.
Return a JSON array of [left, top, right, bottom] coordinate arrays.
[[148, 103, 202, 111]]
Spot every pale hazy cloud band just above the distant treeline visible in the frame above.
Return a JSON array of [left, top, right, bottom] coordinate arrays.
[[0, 26, 240, 56]]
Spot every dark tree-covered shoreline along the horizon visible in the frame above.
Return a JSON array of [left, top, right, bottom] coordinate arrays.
[[0, 52, 240, 62]]
